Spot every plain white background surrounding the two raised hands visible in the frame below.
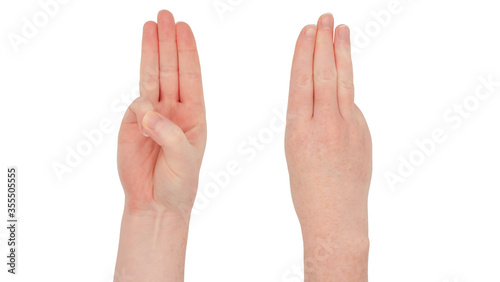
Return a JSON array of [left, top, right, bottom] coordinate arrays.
[[0, 0, 500, 282]]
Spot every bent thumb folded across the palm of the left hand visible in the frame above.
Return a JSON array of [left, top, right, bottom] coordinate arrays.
[[142, 111, 191, 162]]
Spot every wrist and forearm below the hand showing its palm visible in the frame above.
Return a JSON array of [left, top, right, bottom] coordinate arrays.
[[115, 198, 189, 281]]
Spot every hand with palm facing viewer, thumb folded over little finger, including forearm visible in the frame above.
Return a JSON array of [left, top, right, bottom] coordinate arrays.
[[114, 11, 207, 282]]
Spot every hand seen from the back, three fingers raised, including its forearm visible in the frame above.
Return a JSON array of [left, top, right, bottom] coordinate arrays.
[[285, 14, 372, 282]]
